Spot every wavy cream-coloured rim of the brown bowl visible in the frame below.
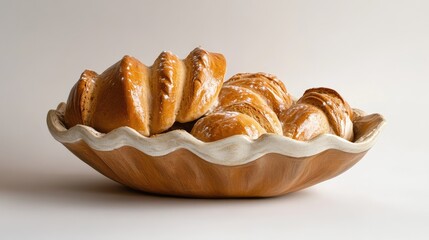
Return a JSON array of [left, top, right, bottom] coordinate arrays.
[[47, 103, 385, 166]]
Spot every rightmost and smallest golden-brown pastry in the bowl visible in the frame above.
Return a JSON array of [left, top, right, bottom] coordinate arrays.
[[279, 88, 353, 141]]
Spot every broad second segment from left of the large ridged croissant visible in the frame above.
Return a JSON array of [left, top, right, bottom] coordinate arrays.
[[88, 56, 150, 135]]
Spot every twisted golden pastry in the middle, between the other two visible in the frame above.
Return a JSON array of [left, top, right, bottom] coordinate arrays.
[[191, 73, 293, 142]]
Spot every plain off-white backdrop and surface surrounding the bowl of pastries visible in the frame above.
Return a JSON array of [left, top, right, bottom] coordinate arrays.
[[0, 0, 429, 239]]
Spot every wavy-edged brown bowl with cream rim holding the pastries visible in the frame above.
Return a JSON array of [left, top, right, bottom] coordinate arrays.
[[47, 103, 385, 198]]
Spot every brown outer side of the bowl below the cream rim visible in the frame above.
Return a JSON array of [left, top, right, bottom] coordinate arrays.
[[63, 140, 367, 198]]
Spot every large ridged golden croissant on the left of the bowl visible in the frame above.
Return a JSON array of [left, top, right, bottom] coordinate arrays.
[[64, 48, 226, 136]]
